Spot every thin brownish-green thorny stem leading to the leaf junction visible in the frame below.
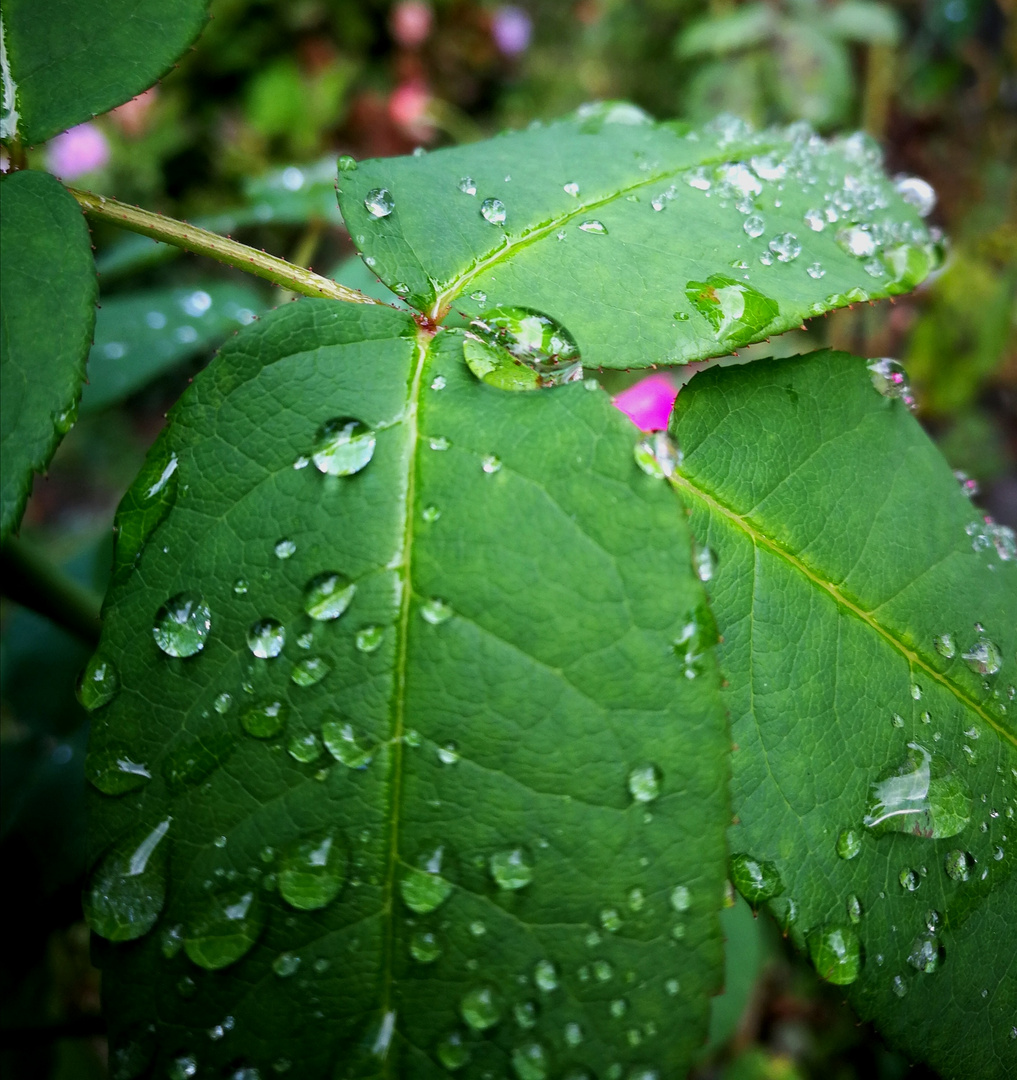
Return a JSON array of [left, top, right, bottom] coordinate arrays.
[[68, 188, 381, 303]]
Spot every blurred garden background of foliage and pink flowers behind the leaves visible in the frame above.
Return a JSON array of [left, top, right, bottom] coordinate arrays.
[[0, 0, 1017, 1080]]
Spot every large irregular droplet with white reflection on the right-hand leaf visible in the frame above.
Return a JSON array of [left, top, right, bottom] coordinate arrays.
[[862, 743, 972, 839]]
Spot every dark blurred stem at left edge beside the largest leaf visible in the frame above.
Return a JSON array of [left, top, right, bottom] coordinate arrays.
[[0, 538, 101, 649]]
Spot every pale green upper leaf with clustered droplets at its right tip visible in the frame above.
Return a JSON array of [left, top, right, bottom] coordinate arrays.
[[339, 109, 934, 368]]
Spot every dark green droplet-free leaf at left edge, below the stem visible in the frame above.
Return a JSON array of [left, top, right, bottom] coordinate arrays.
[[0, 172, 98, 536]]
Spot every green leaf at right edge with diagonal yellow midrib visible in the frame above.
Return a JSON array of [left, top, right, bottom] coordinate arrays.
[[673, 353, 1017, 1078]]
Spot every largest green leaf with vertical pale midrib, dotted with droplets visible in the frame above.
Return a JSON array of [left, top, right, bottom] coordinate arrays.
[[86, 300, 730, 1080]]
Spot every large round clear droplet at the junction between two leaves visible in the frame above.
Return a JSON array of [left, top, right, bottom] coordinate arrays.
[[463, 307, 583, 390]]
